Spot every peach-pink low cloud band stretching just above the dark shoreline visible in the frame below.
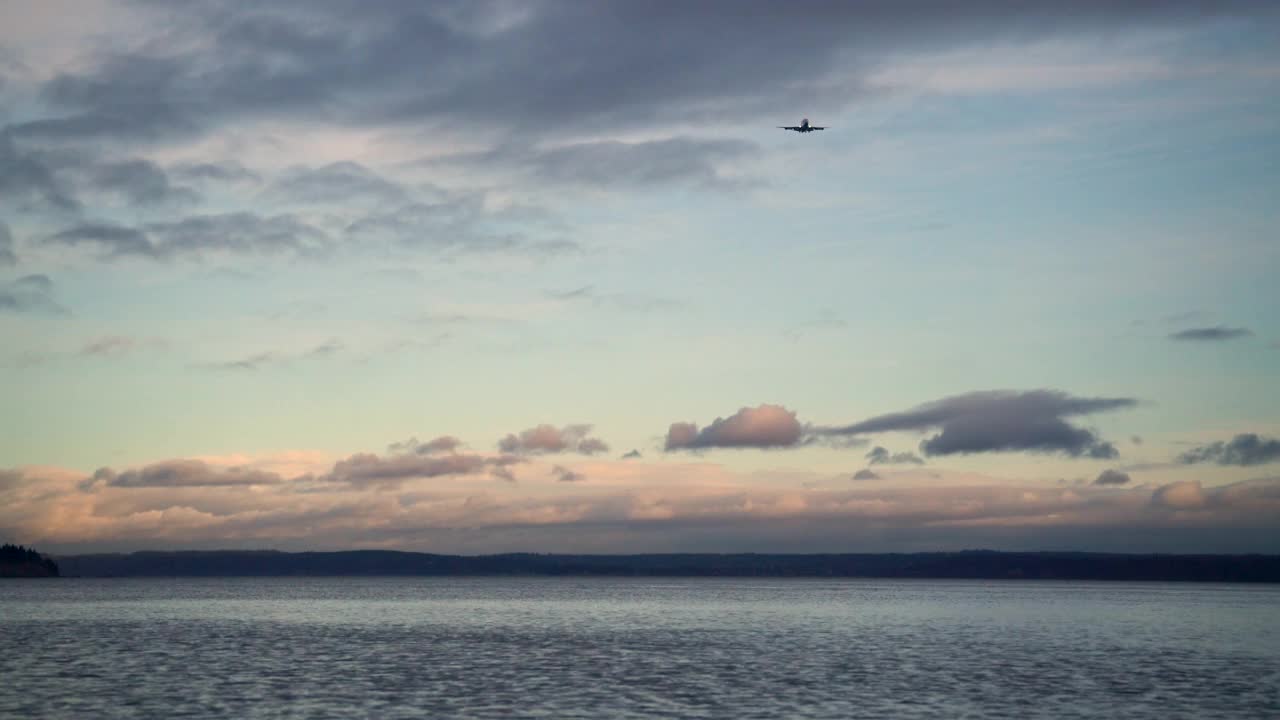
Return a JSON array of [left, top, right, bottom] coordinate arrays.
[[0, 454, 1280, 552]]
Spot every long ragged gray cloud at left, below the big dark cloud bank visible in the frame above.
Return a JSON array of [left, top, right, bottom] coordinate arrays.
[[46, 213, 329, 260]]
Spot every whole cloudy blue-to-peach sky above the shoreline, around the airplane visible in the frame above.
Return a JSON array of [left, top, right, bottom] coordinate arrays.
[[0, 0, 1280, 553]]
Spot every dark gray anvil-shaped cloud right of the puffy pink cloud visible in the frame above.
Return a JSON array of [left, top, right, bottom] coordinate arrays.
[[815, 389, 1138, 459]]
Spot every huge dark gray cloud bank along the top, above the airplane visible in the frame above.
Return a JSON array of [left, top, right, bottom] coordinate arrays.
[[13, 0, 1274, 144]]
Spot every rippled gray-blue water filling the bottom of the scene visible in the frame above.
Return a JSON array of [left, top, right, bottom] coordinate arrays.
[[0, 578, 1280, 719]]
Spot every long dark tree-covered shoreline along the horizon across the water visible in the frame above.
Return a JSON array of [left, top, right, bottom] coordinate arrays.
[[59, 550, 1280, 583]]
